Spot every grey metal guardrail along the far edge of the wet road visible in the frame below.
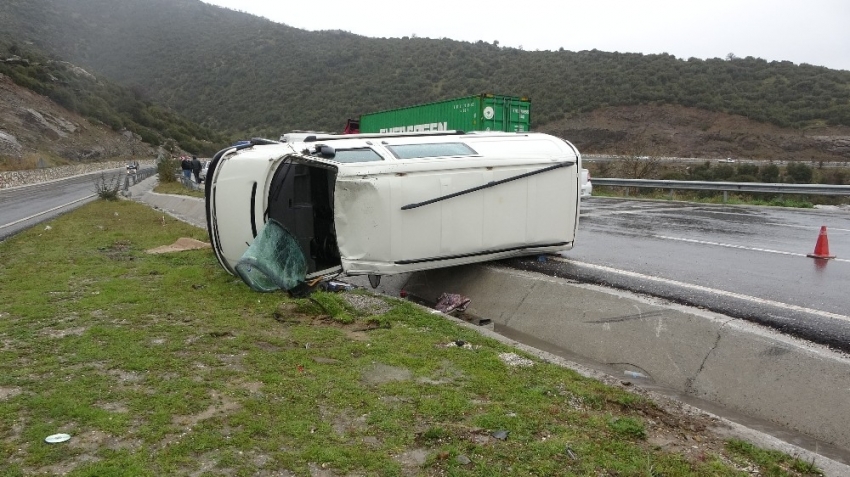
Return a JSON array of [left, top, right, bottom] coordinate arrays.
[[591, 177, 850, 202]]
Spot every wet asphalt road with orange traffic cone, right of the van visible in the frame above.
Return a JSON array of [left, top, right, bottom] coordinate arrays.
[[510, 198, 850, 352]]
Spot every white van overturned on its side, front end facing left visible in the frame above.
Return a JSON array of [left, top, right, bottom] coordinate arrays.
[[206, 131, 581, 289]]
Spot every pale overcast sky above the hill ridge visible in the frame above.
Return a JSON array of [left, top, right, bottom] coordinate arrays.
[[203, 0, 850, 71]]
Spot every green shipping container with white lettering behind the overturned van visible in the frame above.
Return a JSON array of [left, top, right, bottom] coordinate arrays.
[[360, 94, 531, 133]]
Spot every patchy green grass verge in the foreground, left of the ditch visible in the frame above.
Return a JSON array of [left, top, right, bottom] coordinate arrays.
[[0, 200, 818, 476]]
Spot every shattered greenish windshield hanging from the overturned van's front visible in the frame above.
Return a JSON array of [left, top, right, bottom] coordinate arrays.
[[236, 219, 307, 292]]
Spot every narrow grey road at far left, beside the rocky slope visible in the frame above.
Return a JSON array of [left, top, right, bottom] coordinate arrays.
[[0, 169, 124, 240]]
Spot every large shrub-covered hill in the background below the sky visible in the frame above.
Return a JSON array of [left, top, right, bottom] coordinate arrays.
[[0, 0, 850, 161]]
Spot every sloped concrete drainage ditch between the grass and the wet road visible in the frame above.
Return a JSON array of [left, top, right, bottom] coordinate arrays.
[[348, 265, 850, 463]]
